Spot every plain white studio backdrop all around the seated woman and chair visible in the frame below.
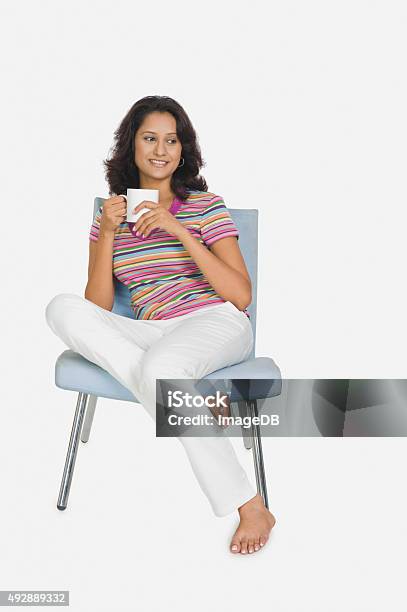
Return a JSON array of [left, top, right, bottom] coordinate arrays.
[[0, 0, 407, 612]]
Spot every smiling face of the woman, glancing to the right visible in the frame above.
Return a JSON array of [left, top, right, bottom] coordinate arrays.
[[134, 112, 182, 180]]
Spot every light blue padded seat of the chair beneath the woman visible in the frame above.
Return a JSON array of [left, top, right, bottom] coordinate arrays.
[[55, 349, 281, 402]]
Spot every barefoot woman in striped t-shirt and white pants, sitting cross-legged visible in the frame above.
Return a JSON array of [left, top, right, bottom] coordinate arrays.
[[46, 96, 275, 554]]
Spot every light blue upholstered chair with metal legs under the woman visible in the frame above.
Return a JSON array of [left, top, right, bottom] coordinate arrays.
[[55, 198, 282, 510]]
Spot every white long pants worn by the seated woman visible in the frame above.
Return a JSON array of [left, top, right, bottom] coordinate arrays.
[[46, 293, 256, 516]]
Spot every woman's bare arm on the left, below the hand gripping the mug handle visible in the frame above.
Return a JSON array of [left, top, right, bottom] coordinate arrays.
[[85, 232, 114, 310]]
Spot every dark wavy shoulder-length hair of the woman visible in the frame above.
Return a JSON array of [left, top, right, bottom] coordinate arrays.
[[103, 96, 208, 199]]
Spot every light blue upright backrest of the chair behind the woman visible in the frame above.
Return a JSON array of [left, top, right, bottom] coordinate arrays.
[[92, 198, 258, 358]]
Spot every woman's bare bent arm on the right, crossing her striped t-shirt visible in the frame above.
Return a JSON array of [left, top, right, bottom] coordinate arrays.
[[177, 226, 252, 310]]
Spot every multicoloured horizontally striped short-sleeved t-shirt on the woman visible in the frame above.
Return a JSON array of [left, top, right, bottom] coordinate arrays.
[[89, 191, 250, 319]]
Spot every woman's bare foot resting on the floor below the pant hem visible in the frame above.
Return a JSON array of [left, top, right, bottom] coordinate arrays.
[[230, 493, 276, 555]]
